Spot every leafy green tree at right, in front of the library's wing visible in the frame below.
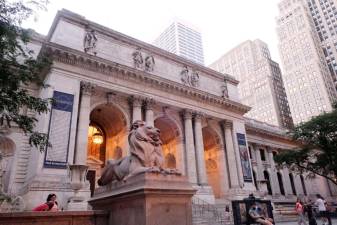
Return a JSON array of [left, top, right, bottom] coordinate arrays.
[[274, 104, 337, 185]]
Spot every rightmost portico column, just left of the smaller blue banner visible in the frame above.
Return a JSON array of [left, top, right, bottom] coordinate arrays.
[[223, 121, 239, 188]]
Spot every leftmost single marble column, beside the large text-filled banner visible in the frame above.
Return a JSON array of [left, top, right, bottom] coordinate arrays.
[[75, 81, 96, 165]]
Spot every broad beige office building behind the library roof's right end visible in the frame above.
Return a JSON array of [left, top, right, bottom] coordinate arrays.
[[210, 40, 293, 128]]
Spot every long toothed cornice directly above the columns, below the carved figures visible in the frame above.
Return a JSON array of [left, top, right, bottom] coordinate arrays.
[[41, 42, 250, 115]]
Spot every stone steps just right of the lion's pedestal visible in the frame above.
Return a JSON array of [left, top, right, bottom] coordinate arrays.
[[192, 196, 231, 225]]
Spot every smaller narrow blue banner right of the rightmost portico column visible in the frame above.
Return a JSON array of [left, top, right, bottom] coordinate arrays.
[[236, 133, 252, 182]]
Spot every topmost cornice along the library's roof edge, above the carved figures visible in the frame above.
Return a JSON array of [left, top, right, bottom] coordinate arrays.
[[47, 9, 239, 85]]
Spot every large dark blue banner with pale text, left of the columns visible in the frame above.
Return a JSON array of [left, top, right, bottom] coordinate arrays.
[[44, 91, 74, 168]]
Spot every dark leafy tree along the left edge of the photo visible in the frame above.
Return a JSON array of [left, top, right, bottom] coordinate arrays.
[[0, 0, 50, 149]]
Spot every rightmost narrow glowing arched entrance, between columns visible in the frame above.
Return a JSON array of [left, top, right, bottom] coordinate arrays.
[[202, 127, 221, 198]]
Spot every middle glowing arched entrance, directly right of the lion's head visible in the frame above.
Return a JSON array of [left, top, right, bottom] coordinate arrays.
[[154, 116, 180, 169]]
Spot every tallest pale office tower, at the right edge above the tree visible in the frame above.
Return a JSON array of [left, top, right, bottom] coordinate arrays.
[[277, 0, 336, 124]]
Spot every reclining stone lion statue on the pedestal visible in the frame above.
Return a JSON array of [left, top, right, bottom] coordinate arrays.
[[98, 120, 180, 186]]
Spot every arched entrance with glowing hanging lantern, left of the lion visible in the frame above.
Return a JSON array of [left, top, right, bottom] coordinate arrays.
[[87, 104, 127, 194]]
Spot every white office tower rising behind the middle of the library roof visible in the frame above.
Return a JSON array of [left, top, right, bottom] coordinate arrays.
[[153, 20, 204, 65]]
